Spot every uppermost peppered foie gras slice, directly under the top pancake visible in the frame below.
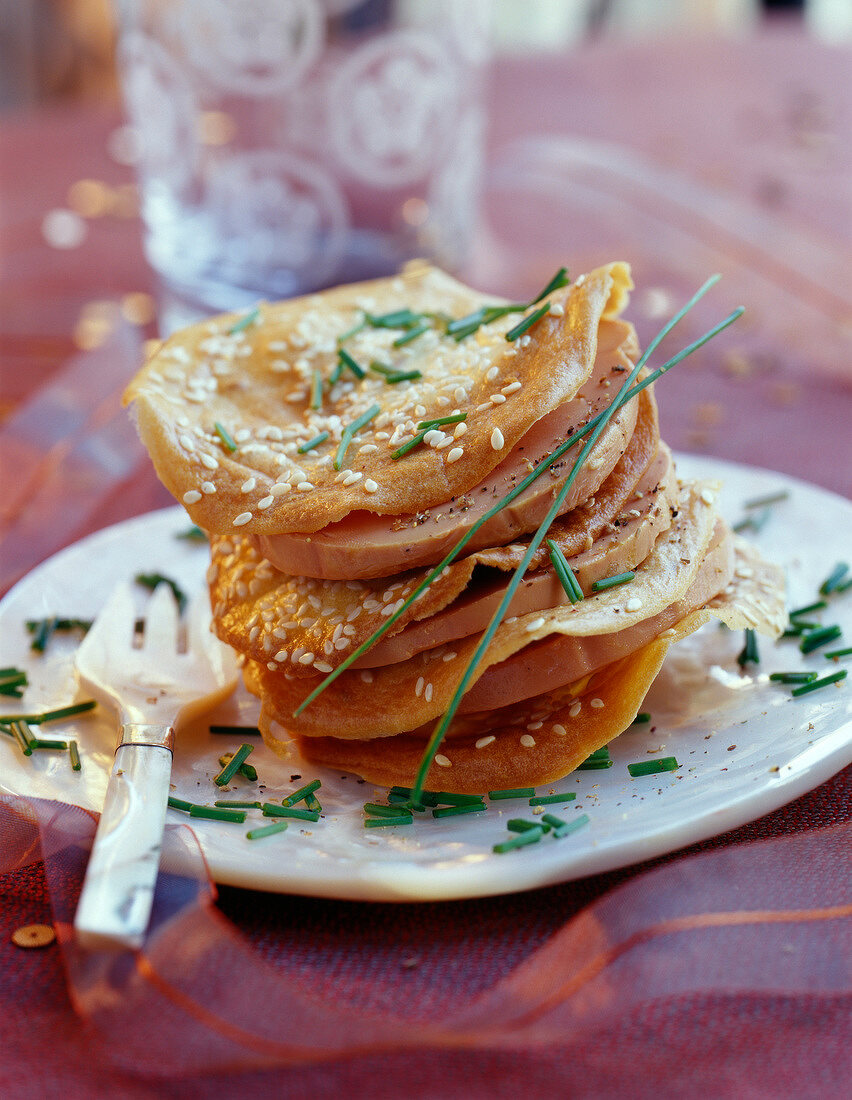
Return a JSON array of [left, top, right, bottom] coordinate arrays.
[[254, 321, 638, 581]]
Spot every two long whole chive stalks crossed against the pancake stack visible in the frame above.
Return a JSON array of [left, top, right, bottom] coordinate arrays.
[[294, 276, 744, 774]]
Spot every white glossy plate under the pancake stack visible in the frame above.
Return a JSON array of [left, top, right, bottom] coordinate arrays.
[[0, 457, 852, 901]]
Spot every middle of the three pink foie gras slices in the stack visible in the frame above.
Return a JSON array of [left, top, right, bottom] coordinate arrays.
[[353, 446, 677, 669]]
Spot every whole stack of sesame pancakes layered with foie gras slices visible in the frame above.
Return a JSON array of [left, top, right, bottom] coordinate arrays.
[[126, 263, 784, 793]]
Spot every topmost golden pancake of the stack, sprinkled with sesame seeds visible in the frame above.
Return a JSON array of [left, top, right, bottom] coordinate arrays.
[[124, 263, 632, 534]]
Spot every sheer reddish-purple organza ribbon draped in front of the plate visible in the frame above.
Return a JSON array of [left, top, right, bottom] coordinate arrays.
[[0, 798, 852, 1096]]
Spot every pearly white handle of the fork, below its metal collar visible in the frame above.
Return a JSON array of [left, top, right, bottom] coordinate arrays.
[[74, 724, 175, 949]]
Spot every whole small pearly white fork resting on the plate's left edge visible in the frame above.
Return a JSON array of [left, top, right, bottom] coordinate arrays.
[[74, 583, 236, 949]]
